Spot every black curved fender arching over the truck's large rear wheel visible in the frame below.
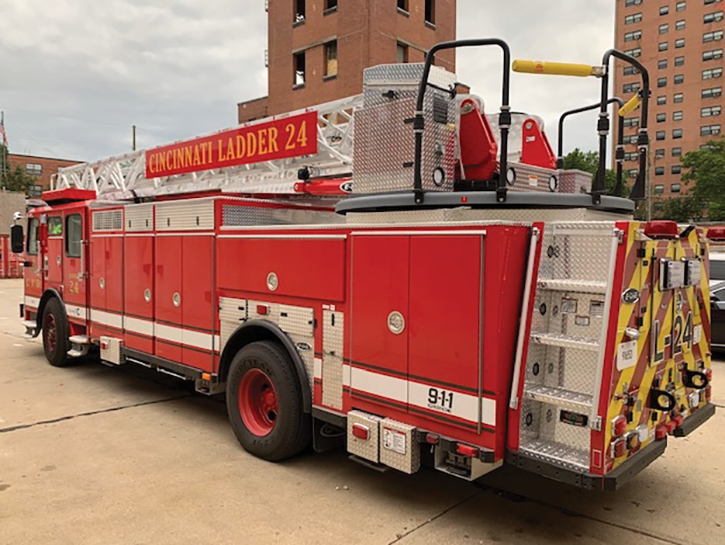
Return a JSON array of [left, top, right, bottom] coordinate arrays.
[[218, 320, 312, 413]]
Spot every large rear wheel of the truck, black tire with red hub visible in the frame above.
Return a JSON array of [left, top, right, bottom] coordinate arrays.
[[227, 341, 312, 462]]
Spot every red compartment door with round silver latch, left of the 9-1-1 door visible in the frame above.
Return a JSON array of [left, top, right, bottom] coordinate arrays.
[[350, 235, 410, 409]]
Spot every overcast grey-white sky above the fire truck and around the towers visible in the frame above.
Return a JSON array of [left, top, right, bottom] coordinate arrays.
[[0, 0, 614, 164]]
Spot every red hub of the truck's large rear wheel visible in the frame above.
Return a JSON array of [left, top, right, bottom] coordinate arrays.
[[239, 369, 279, 437]]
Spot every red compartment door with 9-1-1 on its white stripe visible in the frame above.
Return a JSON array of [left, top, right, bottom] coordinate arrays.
[[408, 234, 486, 429]]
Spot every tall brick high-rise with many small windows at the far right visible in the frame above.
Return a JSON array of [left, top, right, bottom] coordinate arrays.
[[614, 0, 725, 202]]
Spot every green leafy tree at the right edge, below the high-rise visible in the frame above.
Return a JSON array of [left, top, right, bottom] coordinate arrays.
[[682, 137, 725, 221]]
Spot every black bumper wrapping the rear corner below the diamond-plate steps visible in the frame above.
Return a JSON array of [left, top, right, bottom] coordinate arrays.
[[506, 438, 667, 492]]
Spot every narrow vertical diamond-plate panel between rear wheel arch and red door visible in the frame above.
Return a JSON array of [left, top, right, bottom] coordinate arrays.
[[322, 310, 345, 409]]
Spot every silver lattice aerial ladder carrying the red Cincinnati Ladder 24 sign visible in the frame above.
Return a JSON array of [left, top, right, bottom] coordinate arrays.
[[52, 95, 362, 200]]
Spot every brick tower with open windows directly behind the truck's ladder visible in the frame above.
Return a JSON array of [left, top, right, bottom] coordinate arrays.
[[238, 0, 456, 123]]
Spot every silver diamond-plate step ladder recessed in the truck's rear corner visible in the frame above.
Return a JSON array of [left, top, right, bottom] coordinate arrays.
[[520, 222, 621, 471]]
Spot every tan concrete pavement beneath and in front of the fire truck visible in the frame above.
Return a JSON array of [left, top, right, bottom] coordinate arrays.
[[0, 280, 725, 545]]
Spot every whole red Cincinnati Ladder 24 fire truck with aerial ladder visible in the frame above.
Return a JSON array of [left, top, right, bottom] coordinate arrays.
[[9, 40, 712, 489]]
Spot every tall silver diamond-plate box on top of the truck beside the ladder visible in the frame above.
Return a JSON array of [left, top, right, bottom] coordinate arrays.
[[353, 64, 457, 193]]
